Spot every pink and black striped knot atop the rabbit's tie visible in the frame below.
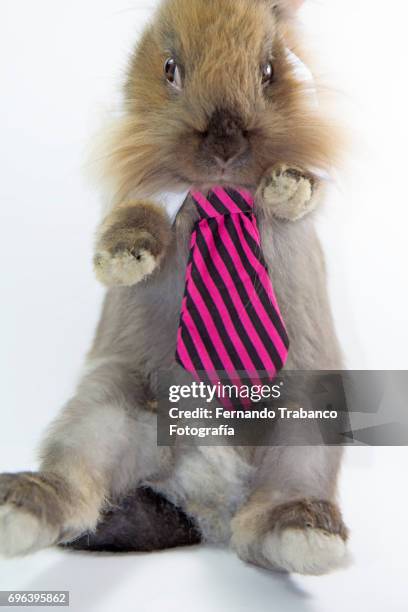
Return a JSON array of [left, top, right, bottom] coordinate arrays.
[[190, 187, 254, 219]]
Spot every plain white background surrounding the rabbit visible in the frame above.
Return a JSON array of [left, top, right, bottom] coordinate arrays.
[[0, 0, 408, 612]]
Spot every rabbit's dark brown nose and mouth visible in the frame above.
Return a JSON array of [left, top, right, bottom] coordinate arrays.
[[203, 109, 248, 165]]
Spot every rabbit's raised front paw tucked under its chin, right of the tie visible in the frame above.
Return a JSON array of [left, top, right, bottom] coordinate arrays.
[[259, 164, 317, 221]]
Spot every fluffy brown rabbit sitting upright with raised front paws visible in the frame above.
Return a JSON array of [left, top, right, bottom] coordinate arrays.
[[0, 0, 347, 574]]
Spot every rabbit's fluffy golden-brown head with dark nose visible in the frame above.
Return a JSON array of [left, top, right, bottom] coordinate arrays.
[[104, 0, 333, 198]]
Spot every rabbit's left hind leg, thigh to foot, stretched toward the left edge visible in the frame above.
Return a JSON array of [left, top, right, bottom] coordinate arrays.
[[0, 361, 164, 556]]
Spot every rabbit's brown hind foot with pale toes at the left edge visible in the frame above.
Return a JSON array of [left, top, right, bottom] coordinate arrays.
[[0, 472, 67, 557]]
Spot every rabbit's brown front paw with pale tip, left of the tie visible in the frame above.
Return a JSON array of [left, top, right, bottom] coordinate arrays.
[[94, 204, 171, 287]]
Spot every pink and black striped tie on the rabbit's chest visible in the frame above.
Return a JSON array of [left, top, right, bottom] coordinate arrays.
[[176, 187, 289, 379]]
